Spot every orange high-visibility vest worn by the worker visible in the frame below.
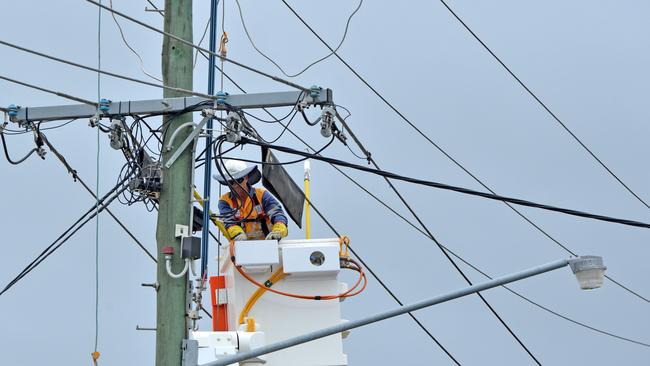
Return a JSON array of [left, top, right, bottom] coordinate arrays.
[[216, 188, 272, 240]]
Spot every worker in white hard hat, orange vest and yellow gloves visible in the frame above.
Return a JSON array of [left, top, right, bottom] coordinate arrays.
[[214, 160, 288, 240]]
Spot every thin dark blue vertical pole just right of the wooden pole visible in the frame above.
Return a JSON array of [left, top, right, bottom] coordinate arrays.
[[201, 0, 219, 281]]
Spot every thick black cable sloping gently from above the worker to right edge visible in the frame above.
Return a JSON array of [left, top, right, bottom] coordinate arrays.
[[241, 138, 650, 229]]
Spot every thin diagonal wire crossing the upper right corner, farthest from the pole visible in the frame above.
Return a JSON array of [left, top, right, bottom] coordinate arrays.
[[440, 0, 650, 209]]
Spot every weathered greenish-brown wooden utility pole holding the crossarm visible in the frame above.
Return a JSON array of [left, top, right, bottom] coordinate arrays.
[[156, 0, 194, 366]]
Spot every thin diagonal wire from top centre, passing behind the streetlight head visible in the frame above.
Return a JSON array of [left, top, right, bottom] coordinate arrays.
[[283, 0, 650, 303]]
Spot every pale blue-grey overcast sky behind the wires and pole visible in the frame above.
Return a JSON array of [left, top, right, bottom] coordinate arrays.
[[0, 0, 650, 365]]
